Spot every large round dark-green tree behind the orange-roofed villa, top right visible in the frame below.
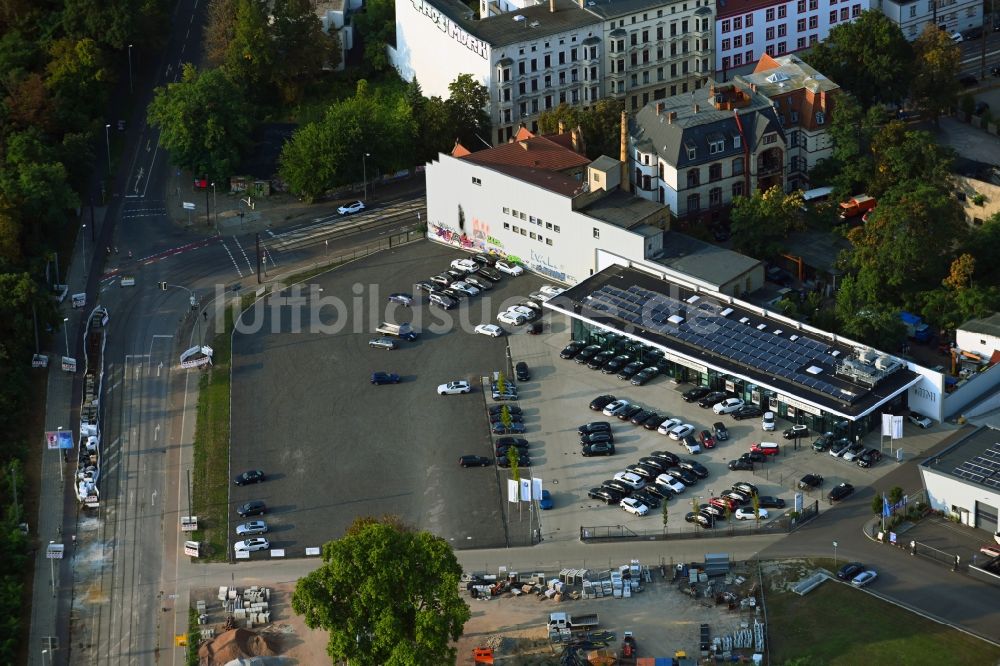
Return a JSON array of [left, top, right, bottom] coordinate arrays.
[[802, 11, 913, 109]]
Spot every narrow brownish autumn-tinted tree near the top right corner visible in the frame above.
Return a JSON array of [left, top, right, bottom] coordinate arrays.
[[911, 22, 962, 123]]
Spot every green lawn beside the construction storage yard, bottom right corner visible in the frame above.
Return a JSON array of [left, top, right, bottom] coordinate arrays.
[[766, 581, 1000, 666]]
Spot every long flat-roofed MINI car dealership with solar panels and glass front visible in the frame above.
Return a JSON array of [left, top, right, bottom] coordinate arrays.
[[545, 252, 942, 438]]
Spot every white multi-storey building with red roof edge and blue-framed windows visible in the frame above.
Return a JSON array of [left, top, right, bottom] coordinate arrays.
[[715, 0, 869, 74]]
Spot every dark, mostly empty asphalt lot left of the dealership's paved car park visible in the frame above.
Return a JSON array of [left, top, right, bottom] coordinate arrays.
[[230, 242, 544, 557]]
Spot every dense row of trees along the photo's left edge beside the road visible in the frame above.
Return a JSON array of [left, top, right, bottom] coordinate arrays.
[[0, 0, 169, 663]]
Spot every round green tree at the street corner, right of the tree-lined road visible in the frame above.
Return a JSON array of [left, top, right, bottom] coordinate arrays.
[[147, 64, 252, 181]]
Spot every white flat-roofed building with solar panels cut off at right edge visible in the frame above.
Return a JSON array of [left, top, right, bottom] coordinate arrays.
[[920, 426, 1000, 534]]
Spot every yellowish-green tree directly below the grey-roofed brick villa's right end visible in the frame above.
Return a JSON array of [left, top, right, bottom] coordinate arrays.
[[729, 185, 802, 259]]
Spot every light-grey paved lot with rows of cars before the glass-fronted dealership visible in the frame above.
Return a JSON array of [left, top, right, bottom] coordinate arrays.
[[511, 316, 940, 540]]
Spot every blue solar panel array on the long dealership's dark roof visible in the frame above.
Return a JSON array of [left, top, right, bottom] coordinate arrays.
[[587, 284, 857, 402]]
